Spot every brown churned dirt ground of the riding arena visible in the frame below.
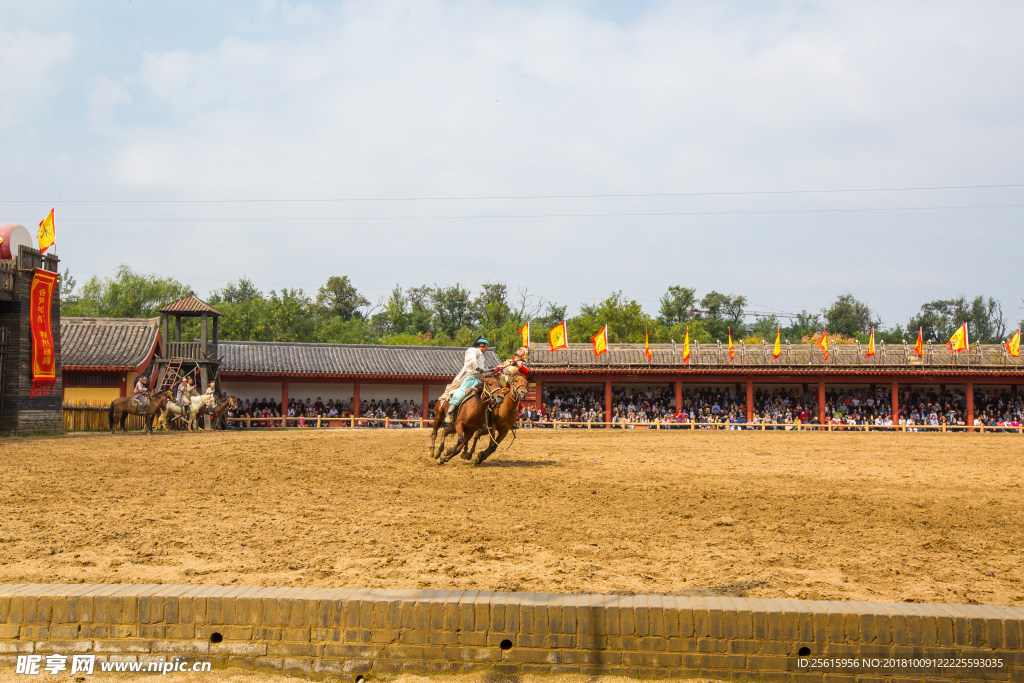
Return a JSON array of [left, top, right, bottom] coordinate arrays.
[[0, 430, 1024, 605]]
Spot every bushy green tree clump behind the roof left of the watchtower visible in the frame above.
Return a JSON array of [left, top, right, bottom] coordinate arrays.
[[61, 264, 191, 317]]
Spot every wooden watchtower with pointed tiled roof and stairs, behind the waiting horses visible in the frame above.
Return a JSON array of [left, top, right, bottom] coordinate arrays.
[[151, 292, 223, 393]]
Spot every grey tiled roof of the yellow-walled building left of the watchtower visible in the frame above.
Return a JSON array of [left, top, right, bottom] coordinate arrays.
[[60, 317, 160, 370]]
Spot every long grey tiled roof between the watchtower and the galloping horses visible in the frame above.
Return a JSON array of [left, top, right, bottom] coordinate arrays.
[[217, 341, 501, 378]]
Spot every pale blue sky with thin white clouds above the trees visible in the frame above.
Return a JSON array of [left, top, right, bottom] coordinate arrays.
[[0, 0, 1024, 325]]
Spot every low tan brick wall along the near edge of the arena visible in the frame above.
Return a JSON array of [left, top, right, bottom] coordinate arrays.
[[0, 584, 1024, 683]]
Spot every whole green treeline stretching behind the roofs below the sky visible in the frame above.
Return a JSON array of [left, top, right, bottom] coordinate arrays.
[[60, 265, 1008, 355]]
